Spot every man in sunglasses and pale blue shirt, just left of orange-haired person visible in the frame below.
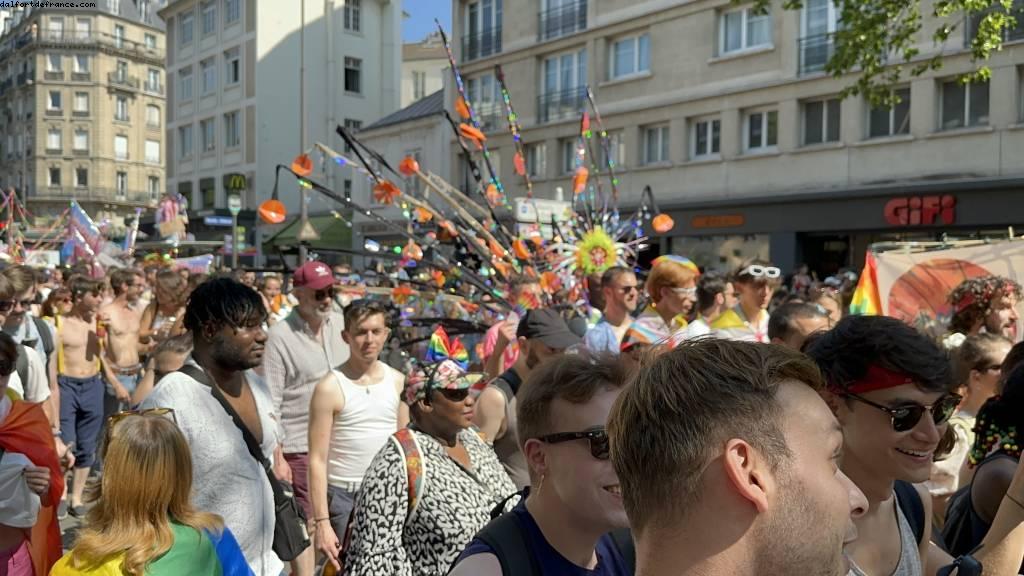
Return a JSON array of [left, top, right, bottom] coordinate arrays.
[[584, 266, 640, 355]]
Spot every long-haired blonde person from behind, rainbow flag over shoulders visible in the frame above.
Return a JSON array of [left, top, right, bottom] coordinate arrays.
[[50, 408, 252, 576]]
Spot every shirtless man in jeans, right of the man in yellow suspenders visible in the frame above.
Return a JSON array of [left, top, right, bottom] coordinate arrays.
[[99, 269, 142, 408]]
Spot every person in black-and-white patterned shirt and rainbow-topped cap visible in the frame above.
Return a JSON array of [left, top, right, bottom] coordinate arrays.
[[344, 332, 516, 576]]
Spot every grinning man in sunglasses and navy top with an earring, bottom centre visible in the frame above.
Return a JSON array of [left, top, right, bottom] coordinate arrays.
[[451, 356, 633, 576]]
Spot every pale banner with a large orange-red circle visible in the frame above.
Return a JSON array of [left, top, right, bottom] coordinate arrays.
[[874, 241, 1024, 337]]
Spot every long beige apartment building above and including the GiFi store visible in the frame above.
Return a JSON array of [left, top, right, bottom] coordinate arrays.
[[449, 0, 1024, 274]]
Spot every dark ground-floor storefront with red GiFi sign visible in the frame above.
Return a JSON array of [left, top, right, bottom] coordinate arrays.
[[662, 179, 1024, 277]]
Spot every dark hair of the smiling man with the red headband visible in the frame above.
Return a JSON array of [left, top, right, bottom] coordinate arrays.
[[807, 316, 953, 393]]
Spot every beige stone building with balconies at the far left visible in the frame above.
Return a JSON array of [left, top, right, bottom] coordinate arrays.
[[0, 0, 166, 230]]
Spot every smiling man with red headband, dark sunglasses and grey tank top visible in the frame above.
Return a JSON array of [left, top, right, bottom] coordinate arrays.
[[807, 316, 1024, 576]]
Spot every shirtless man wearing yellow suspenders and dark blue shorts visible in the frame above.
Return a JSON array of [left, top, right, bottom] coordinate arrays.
[[50, 276, 115, 517]]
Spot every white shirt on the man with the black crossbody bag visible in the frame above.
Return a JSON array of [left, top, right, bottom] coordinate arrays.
[[140, 358, 285, 576]]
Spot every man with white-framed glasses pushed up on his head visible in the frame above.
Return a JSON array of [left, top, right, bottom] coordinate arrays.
[[711, 259, 782, 343]]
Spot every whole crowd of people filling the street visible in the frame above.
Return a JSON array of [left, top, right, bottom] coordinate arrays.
[[0, 255, 1024, 576]]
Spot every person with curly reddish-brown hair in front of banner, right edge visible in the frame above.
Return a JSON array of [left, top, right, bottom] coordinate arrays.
[[942, 276, 1021, 348]]
